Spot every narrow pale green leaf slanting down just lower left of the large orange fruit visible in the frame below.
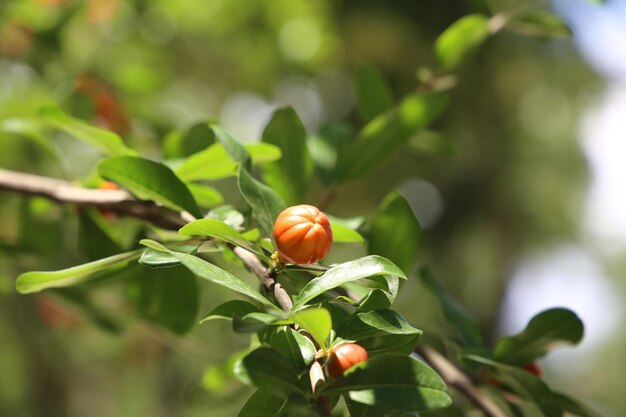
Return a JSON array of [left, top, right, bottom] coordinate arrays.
[[139, 239, 278, 310]]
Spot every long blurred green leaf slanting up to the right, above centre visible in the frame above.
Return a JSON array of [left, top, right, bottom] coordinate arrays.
[[336, 93, 448, 182]]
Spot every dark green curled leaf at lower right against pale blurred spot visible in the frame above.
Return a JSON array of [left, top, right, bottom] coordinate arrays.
[[493, 308, 584, 366]]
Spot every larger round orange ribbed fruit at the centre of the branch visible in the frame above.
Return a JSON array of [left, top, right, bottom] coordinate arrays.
[[274, 204, 333, 264]]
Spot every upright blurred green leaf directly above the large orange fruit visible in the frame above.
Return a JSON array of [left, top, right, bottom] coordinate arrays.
[[261, 107, 313, 204]]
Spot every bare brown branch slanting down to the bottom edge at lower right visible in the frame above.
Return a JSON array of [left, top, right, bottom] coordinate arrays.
[[416, 346, 507, 417]]
